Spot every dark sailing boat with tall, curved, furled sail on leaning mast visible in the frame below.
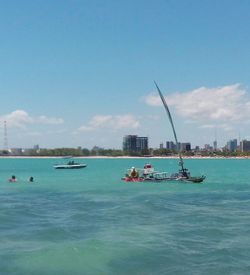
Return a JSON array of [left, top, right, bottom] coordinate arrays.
[[154, 81, 206, 183]]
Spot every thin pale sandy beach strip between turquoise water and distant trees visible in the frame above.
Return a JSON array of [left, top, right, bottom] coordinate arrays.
[[0, 156, 250, 159]]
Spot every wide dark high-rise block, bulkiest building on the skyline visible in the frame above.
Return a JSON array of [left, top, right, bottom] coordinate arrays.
[[123, 135, 148, 153]]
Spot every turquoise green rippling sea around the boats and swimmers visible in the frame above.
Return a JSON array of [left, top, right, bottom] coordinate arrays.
[[0, 158, 250, 275]]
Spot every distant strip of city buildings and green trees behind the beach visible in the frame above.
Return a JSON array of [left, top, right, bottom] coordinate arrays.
[[0, 134, 250, 156]]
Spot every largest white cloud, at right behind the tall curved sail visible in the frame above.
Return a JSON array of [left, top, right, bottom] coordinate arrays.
[[145, 84, 250, 124]]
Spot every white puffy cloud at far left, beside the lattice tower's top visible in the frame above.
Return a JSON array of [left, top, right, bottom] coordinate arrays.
[[0, 110, 64, 129]]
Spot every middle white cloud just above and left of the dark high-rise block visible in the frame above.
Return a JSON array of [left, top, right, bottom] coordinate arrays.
[[78, 114, 140, 131]]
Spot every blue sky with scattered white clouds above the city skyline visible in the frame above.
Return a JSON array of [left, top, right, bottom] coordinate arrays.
[[0, 0, 250, 149]]
